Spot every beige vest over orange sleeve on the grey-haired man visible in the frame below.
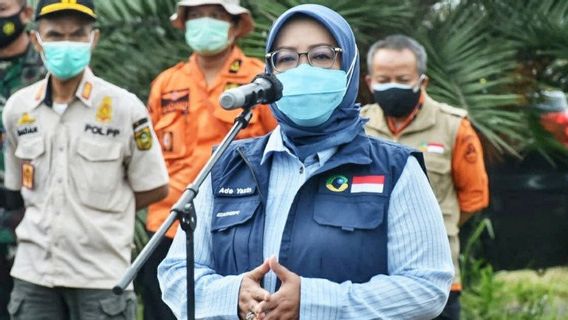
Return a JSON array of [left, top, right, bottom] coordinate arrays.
[[361, 95, 489, 290]]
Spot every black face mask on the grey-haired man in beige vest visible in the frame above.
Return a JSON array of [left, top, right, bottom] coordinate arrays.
[[373, 82, 422, 118]]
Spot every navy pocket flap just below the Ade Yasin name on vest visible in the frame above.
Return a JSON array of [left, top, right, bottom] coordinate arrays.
[[211, 197, 260, 231]]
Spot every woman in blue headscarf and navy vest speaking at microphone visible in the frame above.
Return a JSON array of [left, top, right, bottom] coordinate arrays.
[[158, 5, 453, 320]]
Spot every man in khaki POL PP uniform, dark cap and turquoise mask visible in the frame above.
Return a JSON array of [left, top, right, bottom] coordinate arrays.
[[3, 0, 168, 319]]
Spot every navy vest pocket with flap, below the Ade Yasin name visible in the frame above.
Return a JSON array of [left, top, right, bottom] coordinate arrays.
[[211, 196, 264, 275]]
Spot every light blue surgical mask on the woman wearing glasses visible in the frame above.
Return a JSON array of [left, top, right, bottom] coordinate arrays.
[[276, 48, 357, 127]]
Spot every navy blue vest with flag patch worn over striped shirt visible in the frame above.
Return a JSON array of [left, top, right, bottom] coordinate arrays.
[[209, 135, 424, 283]]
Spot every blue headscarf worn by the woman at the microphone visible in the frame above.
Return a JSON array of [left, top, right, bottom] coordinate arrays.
[[266, 4, 365, 160]]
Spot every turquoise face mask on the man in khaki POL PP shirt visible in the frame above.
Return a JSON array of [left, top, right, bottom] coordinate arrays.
[[36, 33, 93, 80]]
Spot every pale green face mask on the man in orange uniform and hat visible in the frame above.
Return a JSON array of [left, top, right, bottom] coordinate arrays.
[[185, 18, 231, 56]]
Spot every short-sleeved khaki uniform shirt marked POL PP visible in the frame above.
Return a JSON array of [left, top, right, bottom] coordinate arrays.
[[2, 69, 168, 289]]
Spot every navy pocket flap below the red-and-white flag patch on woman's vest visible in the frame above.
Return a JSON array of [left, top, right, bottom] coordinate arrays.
[[314, 195, 388, 231]]
